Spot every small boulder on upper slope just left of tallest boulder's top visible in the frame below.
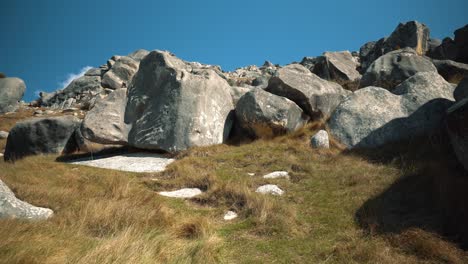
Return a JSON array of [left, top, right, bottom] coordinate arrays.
[[102, 56, 139, 89]]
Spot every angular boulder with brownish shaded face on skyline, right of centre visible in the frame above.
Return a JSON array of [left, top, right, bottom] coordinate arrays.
[[310, 51, 361, 91]]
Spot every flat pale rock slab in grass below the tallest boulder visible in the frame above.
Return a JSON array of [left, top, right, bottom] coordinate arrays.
[[68, 152, 175, 172]]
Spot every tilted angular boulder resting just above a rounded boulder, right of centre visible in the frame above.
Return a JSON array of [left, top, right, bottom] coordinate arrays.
[[266, 64, 350, 119]]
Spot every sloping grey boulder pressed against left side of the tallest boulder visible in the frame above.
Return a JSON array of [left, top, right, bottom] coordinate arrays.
[[81, 88, 129, 145]]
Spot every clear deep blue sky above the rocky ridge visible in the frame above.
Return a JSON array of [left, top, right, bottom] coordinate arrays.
[[0, 0, 468, 101]]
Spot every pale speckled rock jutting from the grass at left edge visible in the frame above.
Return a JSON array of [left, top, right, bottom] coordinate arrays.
[[0, 179, 54, 220]]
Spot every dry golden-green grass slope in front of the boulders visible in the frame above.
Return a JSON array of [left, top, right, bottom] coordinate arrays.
[[0, 112, 468, 263]]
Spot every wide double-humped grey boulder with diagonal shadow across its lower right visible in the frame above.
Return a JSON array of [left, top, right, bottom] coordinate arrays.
[[329, 73, 453, 148]]
